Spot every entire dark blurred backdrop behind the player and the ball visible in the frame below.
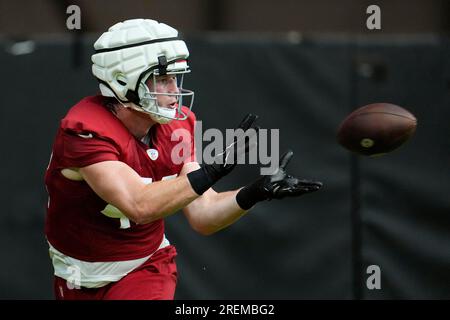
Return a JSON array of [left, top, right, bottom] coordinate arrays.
[[0, 0, 450, 299]]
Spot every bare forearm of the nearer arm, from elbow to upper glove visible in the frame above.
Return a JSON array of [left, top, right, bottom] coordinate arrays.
[[133, 176, 199, 224]]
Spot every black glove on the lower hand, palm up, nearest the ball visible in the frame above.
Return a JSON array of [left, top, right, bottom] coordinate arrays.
[[236, 151, 322, 210]]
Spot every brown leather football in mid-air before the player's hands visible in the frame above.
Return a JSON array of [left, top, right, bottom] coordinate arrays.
[[337, 103, 417, 156]]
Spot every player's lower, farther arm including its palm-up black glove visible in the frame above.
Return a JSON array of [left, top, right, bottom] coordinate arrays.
[[182, 151, 322, 235]]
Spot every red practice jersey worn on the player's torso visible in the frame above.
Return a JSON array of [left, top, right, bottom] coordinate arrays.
[[45, 96, 195, 262]]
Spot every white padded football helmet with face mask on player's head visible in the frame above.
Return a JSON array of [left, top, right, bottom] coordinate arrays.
[[91, 19, 194, 123]]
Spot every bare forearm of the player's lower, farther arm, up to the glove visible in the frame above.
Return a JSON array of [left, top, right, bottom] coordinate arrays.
[[185, 190, 250, 235]]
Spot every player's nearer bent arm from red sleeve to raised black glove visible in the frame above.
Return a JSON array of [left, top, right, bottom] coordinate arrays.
[[79, 114, 256, 224]]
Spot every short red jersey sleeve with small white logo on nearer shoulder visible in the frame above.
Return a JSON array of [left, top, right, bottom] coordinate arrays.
[[61, 130, 120, 168]]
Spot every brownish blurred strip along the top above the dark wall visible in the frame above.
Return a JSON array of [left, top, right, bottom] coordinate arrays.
[[0, 0, 450, 36]]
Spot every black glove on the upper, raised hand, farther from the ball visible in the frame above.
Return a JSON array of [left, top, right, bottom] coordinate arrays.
[[187, 113, 258, 195]]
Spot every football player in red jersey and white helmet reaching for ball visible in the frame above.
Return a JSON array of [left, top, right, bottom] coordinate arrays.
[[45, 19, 321, 299]]
